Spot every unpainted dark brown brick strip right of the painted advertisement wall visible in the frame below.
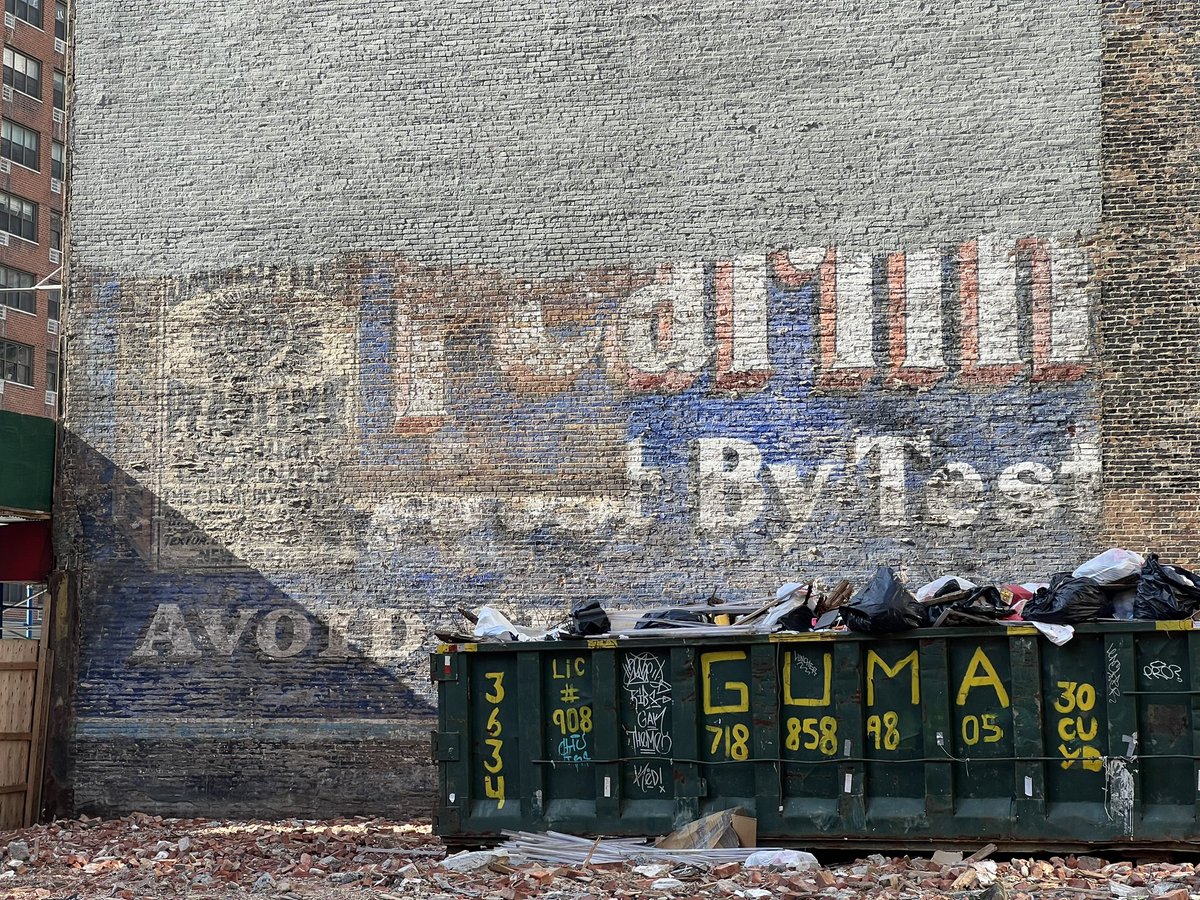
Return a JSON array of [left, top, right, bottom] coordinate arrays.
[[1100, 2, 1200, 554]]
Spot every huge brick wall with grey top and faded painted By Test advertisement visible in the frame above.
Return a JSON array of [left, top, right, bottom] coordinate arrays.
[[55, 0, 1180, 815]]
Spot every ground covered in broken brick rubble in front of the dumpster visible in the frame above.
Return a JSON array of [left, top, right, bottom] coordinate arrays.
[[0, 814, 1200, 900]]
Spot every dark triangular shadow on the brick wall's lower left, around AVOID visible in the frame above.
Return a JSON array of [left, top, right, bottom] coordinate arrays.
[[56, 433, 436, 817]]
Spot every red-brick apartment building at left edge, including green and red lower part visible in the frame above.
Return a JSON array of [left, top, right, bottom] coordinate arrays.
[[0, 0, 68, 606]]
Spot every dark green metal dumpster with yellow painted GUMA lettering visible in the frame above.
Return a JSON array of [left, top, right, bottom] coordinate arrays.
[[431, 620, 1200, 851]]
